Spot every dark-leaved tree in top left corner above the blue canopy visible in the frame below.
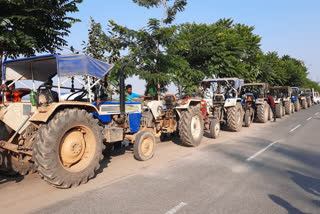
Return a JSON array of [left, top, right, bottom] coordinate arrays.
[[0, 0, 82, 78]]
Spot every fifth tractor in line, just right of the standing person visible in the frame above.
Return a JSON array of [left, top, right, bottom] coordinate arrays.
[[270, 86, 295, 118]]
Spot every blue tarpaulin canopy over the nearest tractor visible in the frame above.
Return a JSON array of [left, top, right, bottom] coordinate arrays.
[[2, 54, 114, 81]]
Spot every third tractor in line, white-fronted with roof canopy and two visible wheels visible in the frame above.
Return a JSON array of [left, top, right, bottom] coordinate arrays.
[[200, 78, 244, 138]]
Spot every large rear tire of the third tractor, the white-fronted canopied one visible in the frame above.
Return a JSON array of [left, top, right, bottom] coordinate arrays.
[[227, 103, 243, 132]]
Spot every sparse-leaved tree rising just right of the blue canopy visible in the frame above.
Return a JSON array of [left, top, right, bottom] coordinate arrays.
[[102, 0, 187, 99]]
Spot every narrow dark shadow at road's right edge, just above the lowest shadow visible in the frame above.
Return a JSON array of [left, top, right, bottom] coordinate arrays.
[[288, 171, 320, 197]]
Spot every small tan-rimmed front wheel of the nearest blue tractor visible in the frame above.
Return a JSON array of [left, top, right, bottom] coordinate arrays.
[[133, 131, 156, 161]]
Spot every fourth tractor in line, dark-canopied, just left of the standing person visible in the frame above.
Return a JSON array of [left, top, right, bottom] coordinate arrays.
[[240, 83, 271, 127]]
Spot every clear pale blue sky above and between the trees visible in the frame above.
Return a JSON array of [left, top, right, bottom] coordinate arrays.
[[64, 0, 320, 93]]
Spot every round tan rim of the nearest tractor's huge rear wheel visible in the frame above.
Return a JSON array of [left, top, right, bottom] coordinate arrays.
[[59, 126, 96, 172]]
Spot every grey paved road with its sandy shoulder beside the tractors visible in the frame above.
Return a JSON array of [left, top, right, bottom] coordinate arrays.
[[0, 106, 320, 214]]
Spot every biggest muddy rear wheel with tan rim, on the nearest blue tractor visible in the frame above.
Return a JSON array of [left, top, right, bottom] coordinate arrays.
[[33, 109, 105, 188]]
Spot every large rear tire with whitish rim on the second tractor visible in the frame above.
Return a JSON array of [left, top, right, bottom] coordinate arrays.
[[179, 106, 204, 146]]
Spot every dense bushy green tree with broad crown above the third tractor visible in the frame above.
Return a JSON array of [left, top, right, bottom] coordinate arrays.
[[165, 19, 262, 92]]
